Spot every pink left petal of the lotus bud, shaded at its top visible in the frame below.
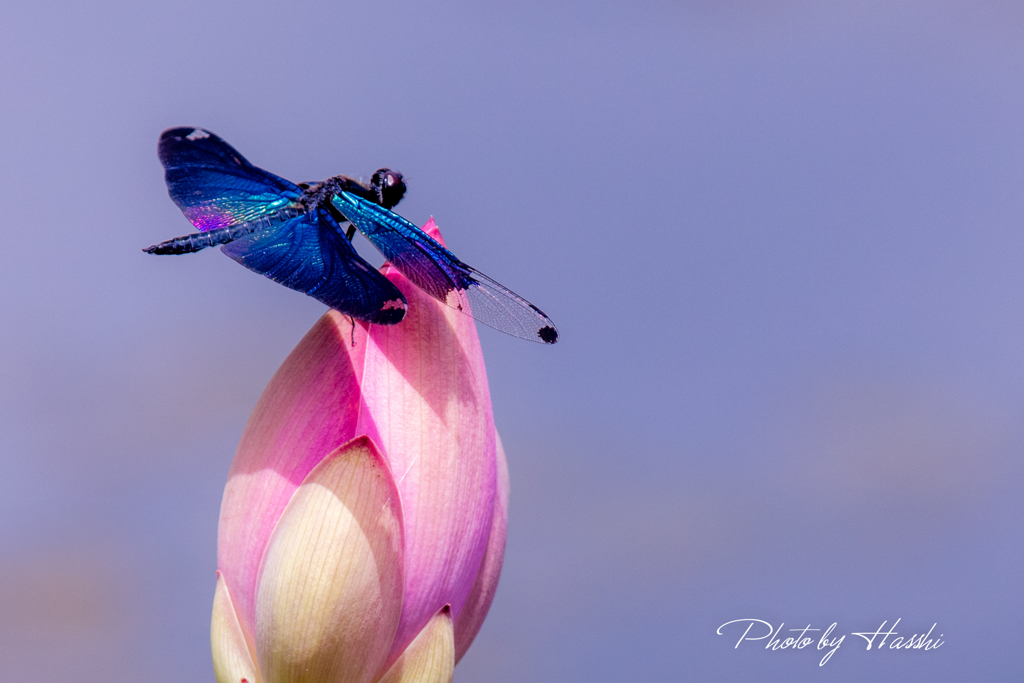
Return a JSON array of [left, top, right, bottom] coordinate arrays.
[[217, 311, 367, 646]]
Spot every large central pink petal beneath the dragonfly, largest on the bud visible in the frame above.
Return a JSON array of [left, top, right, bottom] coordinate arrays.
[[356, 227, 497, 660]]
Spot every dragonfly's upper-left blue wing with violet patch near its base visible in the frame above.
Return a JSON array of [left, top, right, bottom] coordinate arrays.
[[157, 128, 302, 231]]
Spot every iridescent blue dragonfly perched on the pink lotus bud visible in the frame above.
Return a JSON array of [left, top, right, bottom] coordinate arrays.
[[143, 127, 558, 344]]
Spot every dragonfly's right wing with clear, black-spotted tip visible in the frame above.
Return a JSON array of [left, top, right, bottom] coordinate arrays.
[[332, 191, 558, 344]]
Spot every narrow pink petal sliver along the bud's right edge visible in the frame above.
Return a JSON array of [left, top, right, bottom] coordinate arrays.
[[455, 435, 509, 664]]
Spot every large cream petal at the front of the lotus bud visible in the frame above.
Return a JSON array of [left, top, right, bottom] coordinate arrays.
[[256, 436, 404, 683]]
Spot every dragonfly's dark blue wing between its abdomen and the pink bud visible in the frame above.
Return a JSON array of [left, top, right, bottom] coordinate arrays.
[[220, 209, 407, 325]]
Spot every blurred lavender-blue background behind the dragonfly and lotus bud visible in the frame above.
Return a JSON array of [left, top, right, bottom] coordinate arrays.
[[0, 0, 1024, 683]]
